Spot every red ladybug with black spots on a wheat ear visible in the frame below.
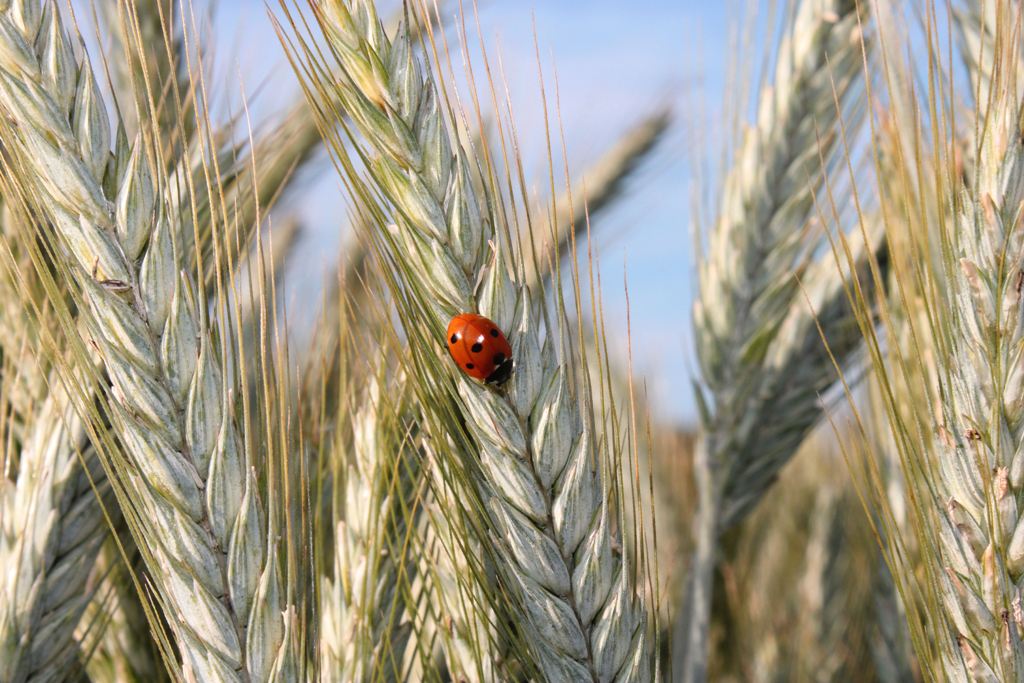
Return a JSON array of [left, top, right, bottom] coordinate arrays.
[[447, 313, 512, 384]]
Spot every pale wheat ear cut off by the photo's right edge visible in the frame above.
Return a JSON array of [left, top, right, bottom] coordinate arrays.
[[917, 80, 1024, 680]]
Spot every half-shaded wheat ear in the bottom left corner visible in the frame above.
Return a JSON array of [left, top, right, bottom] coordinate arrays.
[[0, 387, 110, 683]]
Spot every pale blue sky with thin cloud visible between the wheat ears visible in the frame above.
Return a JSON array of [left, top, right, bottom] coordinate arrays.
[[188, 0, 729, 422]]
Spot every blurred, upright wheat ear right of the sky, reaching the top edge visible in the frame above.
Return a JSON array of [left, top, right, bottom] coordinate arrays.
[[694, 0, 861, 526]]
